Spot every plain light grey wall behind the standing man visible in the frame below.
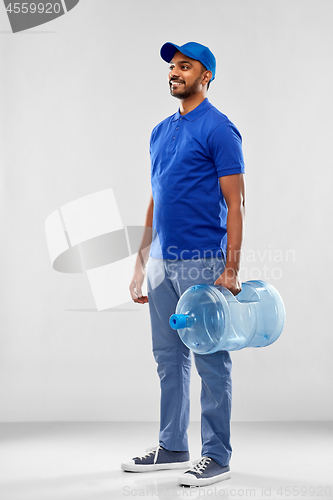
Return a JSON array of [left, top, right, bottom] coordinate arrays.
[[0, 0, 333, 421]]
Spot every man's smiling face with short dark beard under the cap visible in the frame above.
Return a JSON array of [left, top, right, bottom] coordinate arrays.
[[169, 52, 205, 99]]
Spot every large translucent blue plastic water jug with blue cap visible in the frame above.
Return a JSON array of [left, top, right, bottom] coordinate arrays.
[[170, 281, 285, 354]]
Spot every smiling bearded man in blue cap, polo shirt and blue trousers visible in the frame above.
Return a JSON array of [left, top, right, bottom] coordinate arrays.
[[122, 42, 244, 486]]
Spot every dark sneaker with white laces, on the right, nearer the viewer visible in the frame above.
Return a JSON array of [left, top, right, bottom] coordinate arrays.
[[179, 457, 230, 486]]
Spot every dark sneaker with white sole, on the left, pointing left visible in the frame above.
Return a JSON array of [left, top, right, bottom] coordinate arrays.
[[121, 446, 191, 472]]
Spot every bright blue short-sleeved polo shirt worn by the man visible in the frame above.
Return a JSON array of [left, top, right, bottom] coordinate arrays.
[[150, 99, 244, 260]]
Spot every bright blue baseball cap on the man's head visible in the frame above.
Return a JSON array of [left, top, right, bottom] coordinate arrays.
[[161, 42, 216, 82]]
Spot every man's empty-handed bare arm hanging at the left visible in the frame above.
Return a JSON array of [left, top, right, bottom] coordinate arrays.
[[129, 195, 154, 304]]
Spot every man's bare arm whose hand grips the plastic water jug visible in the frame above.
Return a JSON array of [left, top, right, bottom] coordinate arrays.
[[214, 174, 245, 295]]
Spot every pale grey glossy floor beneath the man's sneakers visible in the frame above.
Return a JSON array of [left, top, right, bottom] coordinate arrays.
[[0, 422, 333, 500]]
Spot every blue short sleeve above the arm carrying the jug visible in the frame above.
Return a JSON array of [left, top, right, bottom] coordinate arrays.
[[208, 120, 244, 177]]
